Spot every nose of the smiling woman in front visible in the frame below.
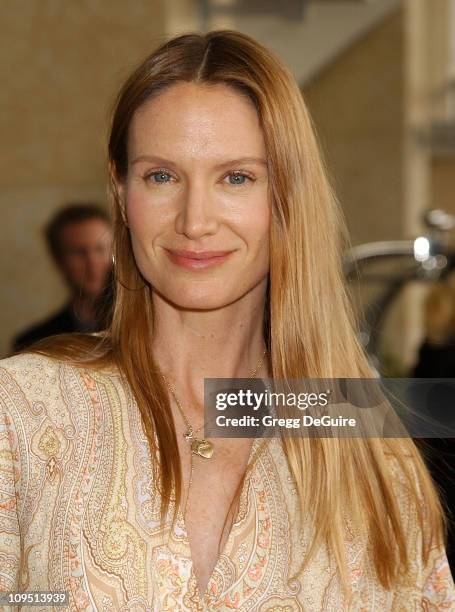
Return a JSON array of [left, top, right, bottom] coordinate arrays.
[[175, 181, 218, 240]]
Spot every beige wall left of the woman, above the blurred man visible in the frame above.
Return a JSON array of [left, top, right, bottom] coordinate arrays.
[[0, 0, 164, 356]]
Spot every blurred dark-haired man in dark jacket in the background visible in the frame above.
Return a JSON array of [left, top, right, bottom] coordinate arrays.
[[13, 204, 113, 351]]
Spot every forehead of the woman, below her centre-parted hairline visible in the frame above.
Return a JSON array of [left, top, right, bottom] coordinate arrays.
[[128, 82, 265, 159]]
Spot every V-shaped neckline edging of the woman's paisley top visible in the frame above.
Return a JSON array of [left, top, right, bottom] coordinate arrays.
[[177, 438, 266, 609]]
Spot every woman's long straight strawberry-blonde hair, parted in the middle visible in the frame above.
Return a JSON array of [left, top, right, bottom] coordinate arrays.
[[21, 30, 444, 593]]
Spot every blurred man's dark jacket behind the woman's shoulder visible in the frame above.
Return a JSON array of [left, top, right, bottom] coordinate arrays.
[[13, 302, 100, 351]]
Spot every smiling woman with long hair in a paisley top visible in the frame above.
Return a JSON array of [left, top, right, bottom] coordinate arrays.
[[0, 31, 455, 612]]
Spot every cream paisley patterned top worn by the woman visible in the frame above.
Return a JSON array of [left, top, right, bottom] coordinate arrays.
[[0, 354, 455, 612]]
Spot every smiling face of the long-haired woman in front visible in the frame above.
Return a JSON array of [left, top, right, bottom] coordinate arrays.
[[118, 82, 271, 310]]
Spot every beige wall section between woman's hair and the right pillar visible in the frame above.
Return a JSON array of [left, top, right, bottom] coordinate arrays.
[[304, 10, 403, 244]]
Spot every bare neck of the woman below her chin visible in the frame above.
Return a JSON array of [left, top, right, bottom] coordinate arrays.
[[152, 283, 269, 411]]
